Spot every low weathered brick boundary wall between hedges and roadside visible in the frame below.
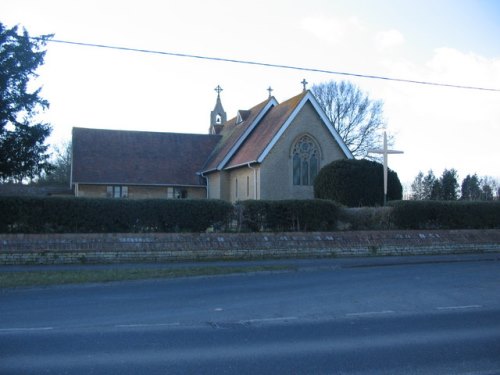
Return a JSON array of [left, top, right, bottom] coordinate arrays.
[[0, 229, 500, 265]]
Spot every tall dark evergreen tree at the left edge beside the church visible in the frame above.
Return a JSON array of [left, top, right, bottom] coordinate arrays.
[[0, 23, 51, 182]]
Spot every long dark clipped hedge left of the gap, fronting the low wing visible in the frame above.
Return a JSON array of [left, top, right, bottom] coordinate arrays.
[[0, 197, 233, 233]]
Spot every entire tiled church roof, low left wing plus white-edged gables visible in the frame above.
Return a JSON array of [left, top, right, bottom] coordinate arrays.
[[72, 91, 353, 186]]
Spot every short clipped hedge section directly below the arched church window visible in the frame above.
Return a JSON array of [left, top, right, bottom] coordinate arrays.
[[237, 199, 339, 232]]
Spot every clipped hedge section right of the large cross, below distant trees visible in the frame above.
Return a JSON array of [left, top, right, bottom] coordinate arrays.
[[390, 201, 500, 229]]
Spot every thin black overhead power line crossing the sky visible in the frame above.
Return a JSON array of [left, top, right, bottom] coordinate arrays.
[[43, 38, 500, 92]]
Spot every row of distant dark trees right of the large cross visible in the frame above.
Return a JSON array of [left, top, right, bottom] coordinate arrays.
[[410, 169, 500, 201]]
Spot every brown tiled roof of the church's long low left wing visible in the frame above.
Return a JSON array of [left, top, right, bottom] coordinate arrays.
[[72, 128, 221, 186]]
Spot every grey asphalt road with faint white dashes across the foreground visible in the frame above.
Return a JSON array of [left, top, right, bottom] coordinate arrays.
[[0, 257, 500, 374]]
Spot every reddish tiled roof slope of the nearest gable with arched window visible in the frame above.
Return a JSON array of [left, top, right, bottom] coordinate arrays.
[[226, 92, 307, 168]]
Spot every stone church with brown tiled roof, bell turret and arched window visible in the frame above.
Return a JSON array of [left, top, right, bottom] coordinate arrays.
[[71, 80, 353, 202]]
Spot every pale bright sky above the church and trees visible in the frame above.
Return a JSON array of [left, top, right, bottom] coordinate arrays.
[[0, 0, 500, 187]]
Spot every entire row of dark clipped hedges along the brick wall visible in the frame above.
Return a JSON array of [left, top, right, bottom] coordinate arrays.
[[0, 197, 500, 233]]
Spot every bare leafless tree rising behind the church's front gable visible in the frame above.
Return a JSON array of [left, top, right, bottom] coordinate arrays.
[[311, 81, 385, 158]]
